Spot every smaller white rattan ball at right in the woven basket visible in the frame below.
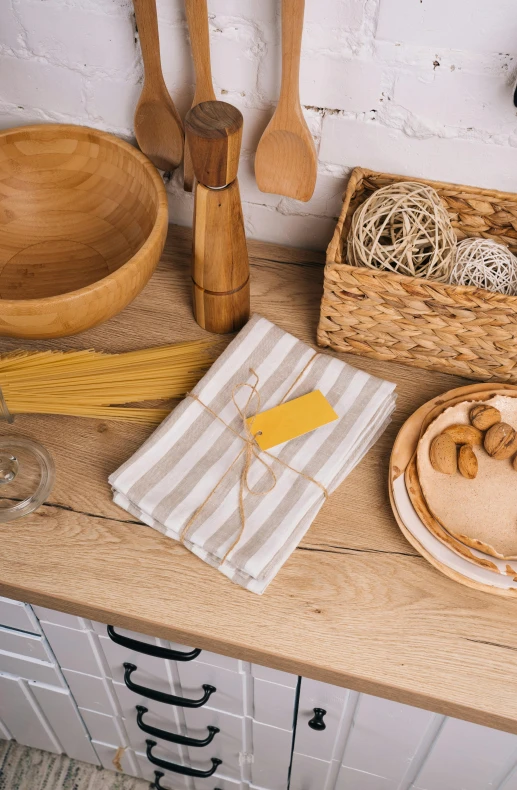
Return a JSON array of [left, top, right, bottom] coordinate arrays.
[[450, 239, 517, 295]]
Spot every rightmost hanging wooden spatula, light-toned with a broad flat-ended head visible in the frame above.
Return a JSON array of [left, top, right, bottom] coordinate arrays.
[[255, 0, 318, 201]]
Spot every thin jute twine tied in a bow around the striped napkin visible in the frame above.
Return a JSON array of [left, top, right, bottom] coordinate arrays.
[[180, 352, 328, 563]]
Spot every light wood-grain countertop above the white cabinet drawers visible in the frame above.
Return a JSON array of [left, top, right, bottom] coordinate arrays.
[[0, 228, 517, 733]]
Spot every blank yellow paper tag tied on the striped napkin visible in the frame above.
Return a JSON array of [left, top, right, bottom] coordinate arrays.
[[247, 390, 338, 450]]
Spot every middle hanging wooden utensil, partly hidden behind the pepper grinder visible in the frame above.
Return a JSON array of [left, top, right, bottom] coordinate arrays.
[[183, 0, 216, 192]]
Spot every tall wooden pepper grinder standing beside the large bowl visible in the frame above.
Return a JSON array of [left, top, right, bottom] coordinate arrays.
[[185, 101, 250, 333]]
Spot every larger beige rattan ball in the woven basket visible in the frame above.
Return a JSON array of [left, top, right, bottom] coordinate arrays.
[[348, 181, 457, 282]]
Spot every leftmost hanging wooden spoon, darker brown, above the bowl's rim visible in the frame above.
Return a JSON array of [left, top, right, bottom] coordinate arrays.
[[133, 0, 184, 171]]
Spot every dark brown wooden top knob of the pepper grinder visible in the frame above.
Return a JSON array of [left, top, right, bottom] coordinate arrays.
[[185, 101, 244, 189]]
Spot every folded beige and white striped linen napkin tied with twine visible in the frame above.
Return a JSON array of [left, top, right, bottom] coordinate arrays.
[[110, 315, 395, 593]]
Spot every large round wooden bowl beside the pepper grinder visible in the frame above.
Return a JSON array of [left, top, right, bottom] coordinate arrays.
[[0, 124, 168, 338]]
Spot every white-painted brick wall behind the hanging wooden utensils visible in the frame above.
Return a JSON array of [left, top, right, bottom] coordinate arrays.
[[0, 0, 517, 248]]
